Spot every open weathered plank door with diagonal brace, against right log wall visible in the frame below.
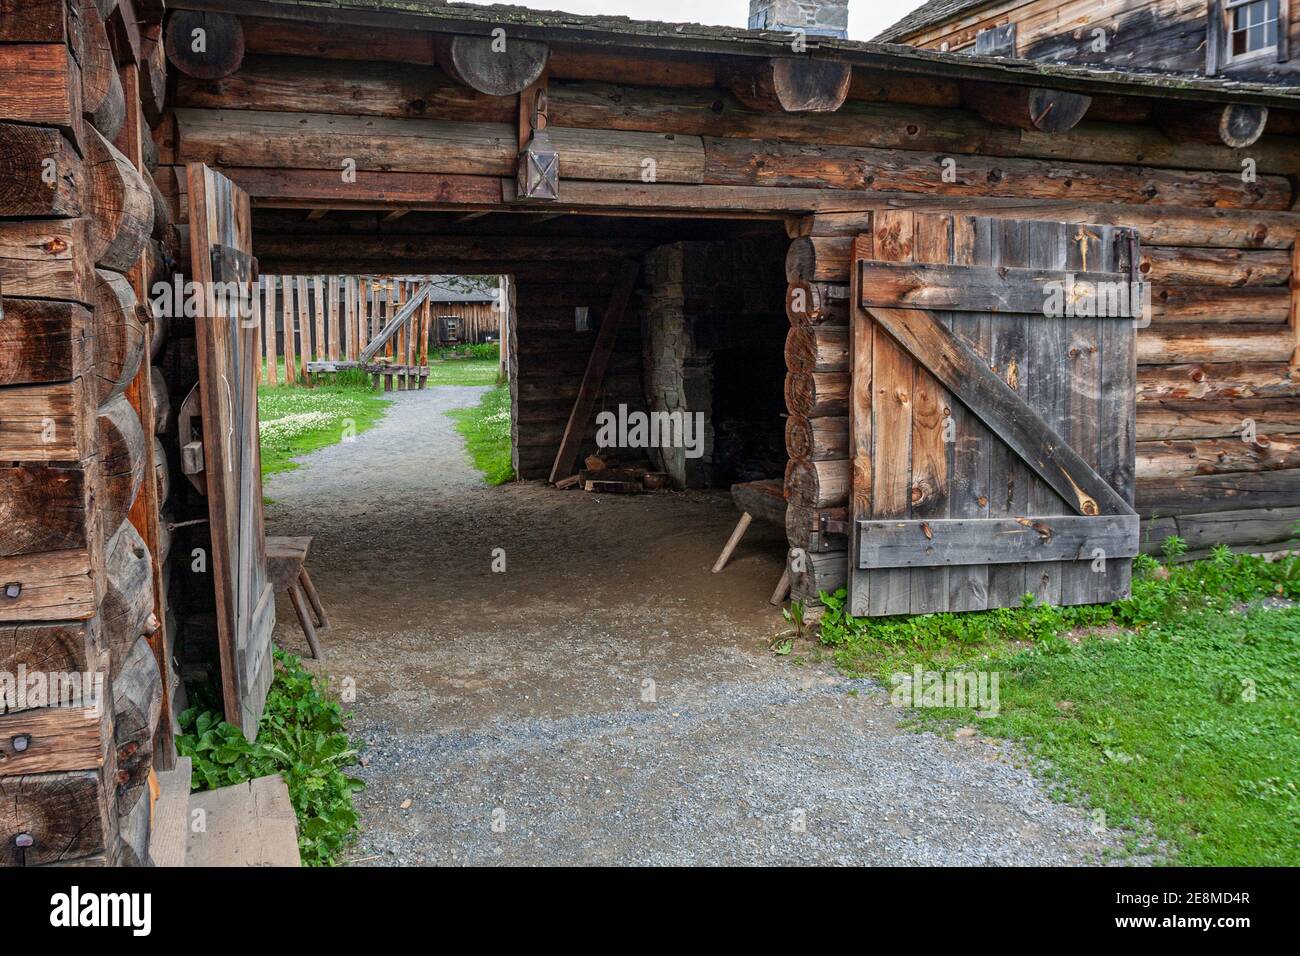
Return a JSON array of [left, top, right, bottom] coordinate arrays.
[[849, 211, 1145, 617]]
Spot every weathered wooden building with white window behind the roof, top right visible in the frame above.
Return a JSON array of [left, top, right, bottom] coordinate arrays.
[[876, 0, 1300, 86]]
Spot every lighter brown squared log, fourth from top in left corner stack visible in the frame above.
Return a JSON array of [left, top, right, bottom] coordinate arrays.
[[0, 219, 95, 306]]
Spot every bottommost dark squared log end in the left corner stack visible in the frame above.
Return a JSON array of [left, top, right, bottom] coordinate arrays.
[[0, 770, 113, 866]]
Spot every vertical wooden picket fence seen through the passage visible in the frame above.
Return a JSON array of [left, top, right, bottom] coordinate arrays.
[[254, 276, 437, 385]]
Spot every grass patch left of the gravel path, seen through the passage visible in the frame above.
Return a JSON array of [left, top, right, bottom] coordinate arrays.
[[257, 373, 390, 479]]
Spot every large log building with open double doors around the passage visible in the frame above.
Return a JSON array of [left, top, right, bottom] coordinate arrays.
[[0, 0, 1300, 865]]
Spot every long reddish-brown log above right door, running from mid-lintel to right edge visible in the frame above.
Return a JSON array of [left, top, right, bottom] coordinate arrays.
[[703, 137, 1291, 209]]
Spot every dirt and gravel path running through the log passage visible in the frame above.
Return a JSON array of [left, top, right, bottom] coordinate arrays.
[[267, 388, 1115, 866]]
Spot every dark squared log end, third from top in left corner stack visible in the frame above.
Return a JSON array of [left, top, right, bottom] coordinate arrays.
[[0, 122, 86, 217]]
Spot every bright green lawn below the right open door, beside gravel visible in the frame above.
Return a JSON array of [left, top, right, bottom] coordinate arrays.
[[820, 545, 1300, 866]]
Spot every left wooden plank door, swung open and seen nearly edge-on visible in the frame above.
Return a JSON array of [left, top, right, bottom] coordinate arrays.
[[186, 163, 276, 740]]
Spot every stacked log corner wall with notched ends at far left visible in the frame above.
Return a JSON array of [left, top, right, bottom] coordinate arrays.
[[0, 0, 173, 866]]
